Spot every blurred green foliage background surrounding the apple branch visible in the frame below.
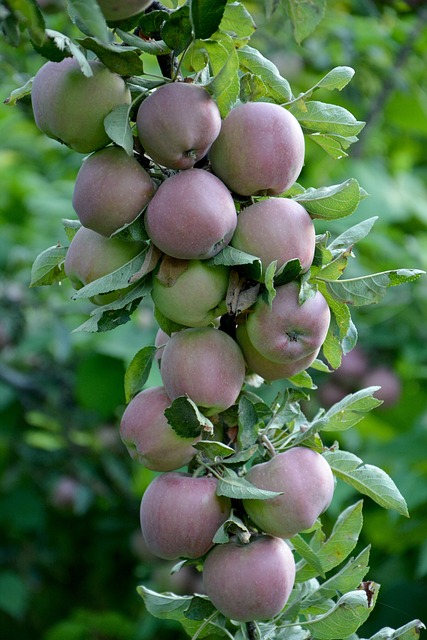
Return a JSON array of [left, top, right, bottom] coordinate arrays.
[[0, 0, 427, 640]]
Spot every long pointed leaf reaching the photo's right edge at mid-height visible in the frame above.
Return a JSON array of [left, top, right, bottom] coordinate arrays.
[[315, 269, 425, 307]]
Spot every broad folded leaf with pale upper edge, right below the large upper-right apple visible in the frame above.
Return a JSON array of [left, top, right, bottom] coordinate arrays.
[[293, 178, 361, 220]]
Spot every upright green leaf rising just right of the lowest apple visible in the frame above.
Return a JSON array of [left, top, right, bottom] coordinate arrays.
[[296, 500, 363, 582]]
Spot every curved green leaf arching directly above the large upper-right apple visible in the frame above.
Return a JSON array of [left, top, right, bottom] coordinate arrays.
[[237, 45, 292, 104]]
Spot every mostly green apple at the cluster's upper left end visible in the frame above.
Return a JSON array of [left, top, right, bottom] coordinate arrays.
[[31, 58, 131, 153]]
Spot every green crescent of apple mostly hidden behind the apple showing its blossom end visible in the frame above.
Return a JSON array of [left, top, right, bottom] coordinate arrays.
[[236, 323, 319, 382]]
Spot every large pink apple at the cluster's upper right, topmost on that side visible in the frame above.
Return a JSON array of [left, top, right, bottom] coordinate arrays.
[[209, 102, 305, 196]]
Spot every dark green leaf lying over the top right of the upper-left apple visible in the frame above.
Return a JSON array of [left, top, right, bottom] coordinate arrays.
[[77, 38, 144, 76]]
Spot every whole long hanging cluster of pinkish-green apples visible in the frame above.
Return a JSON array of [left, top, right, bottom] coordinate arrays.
[[32, 56, 334, 621]]
